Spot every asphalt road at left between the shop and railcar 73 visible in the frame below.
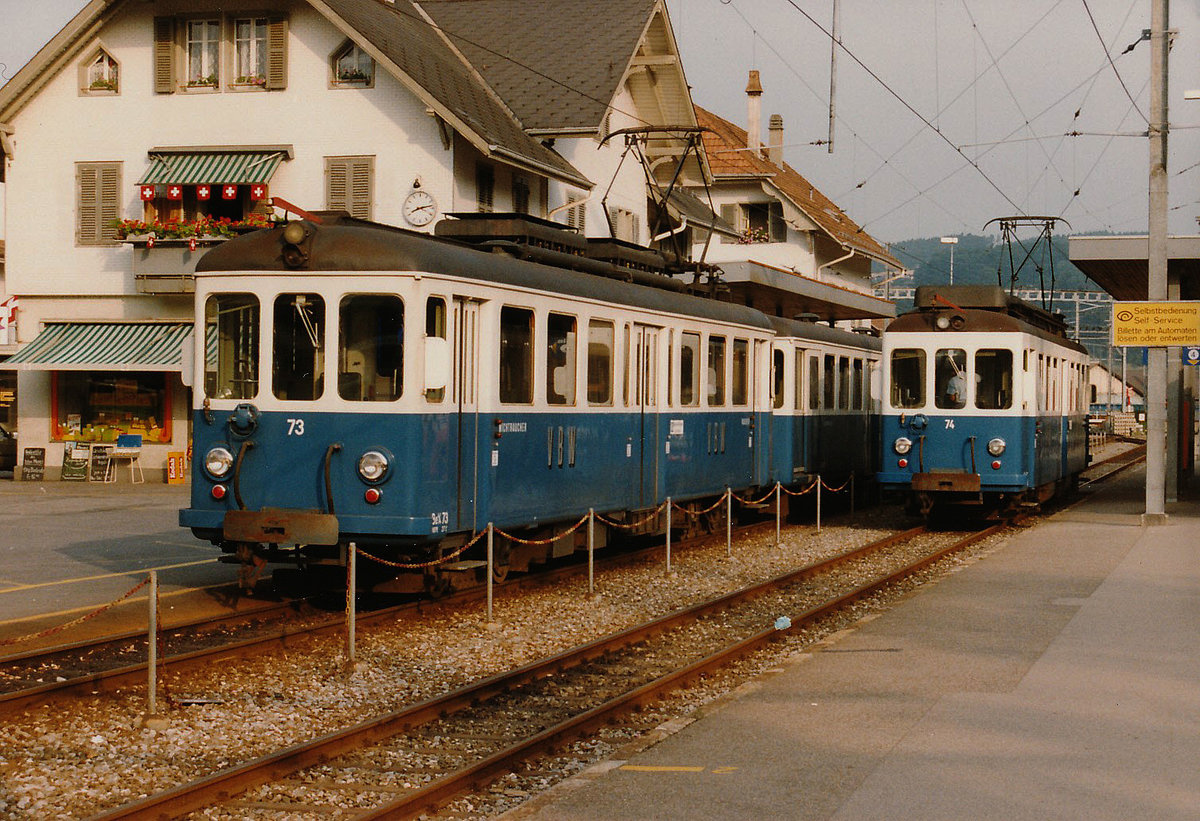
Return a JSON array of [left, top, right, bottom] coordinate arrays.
[[0, 481, 248, 654]]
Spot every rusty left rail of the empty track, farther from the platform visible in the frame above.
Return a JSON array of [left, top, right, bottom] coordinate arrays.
[[91, 526, 931, 821]]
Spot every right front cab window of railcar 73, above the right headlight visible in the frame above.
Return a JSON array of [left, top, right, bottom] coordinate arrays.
[[337, 294, 404, 402]]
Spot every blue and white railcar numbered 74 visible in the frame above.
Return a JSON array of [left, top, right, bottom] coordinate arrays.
[[878, 286, 1088, 514]]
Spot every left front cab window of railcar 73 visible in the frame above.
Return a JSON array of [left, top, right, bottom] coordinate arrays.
[[204, 294, 259, 398]]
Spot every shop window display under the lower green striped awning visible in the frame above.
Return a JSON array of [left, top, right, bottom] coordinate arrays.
[[52, 371, 170, 444]]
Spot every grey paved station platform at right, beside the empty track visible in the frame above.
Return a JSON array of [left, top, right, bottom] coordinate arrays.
[[511, 467, 1200, 821]]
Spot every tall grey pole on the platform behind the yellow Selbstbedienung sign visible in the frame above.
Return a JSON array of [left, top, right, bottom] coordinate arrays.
[[1142, 0, 1177, 525]]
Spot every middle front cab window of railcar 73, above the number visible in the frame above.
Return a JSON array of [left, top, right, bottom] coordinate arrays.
[[271, 294, 325, 401]]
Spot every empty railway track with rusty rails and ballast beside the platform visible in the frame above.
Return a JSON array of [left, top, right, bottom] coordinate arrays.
[[87, 525, 1006, 820]]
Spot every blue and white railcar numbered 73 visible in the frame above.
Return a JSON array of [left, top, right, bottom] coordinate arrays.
[[180, 216, 844, 590]]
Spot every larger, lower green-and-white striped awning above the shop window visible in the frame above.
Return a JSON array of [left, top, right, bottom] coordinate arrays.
[[0, 322, 192, 371]]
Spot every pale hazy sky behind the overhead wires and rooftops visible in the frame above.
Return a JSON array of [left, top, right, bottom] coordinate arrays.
[[7, 0, 1200, 241]]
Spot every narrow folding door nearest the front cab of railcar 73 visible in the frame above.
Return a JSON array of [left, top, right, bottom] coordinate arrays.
[[452, 296, 479, 531]]
